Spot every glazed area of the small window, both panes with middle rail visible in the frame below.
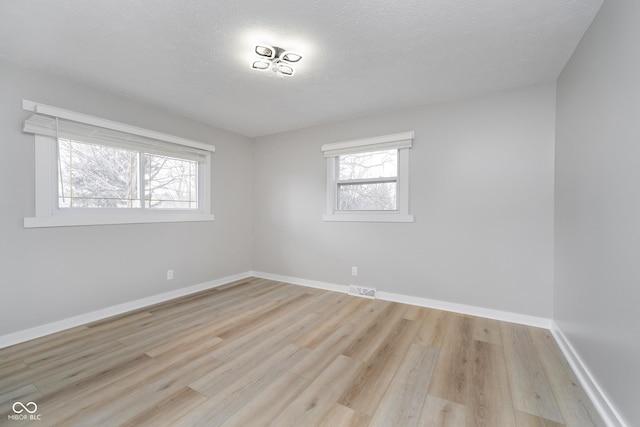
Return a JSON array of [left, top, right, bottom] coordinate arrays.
[[336, 150, 398, 211]]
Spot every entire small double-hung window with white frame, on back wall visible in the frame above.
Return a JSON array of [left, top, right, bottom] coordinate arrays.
[[322, 132, 413, 222]]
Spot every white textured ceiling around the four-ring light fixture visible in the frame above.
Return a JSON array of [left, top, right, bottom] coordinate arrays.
[[0, 0, 603, 137]]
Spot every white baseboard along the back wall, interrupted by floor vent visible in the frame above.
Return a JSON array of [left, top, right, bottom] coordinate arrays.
[[250, 271, 551, 329]]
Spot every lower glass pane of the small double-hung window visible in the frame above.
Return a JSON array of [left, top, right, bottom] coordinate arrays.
[[338, 182, 397, 211]]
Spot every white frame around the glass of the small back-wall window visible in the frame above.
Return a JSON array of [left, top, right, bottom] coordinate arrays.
[[322, 131, 414, 222]]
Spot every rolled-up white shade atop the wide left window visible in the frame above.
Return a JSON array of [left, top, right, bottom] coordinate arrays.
[[23, 114, 215, 162]]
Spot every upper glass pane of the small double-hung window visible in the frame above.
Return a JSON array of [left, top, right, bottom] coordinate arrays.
[[338, 150, 398, 180]]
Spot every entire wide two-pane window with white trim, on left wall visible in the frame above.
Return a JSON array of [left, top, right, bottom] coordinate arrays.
[[24, 101, 215, 227]]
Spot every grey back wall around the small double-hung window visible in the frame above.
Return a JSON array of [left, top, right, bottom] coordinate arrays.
[[253, 84, 555, 318]]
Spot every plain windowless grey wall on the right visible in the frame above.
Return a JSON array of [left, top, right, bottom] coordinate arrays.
[[554, 0, 640, 425]]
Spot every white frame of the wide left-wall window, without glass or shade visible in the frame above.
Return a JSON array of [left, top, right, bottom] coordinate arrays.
[[23, 100, 215, 228]]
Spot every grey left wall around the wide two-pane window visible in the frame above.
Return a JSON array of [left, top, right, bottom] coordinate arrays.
[[0, 61, 252, 336]]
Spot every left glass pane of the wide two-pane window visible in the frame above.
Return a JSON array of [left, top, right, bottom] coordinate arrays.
[[58, 139, 140, 208]]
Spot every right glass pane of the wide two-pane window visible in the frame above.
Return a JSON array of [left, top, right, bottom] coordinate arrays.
[[145, 154, 198, 209]]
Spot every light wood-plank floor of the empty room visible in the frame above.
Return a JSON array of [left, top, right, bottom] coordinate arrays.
[[0, 279, 603, 427]]
